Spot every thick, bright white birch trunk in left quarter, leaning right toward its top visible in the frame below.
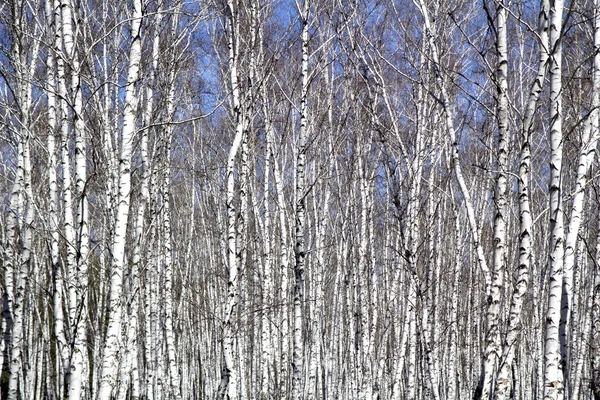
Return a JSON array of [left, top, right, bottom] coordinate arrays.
[[98, 0, 142, 400]]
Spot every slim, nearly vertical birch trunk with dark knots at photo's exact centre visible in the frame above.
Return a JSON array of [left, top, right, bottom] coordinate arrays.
[[292, 0, 310, 400]]
